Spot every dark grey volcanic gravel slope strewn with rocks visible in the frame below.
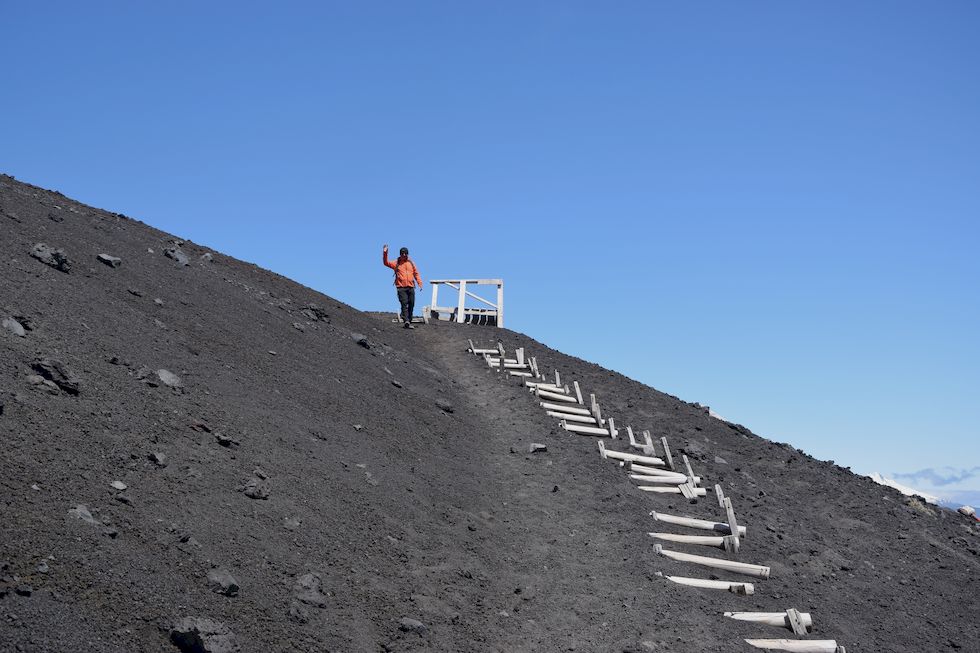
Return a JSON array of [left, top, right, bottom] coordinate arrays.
[[0, 176, 980, 653]]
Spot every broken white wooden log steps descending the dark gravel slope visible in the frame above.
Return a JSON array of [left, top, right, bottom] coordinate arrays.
[[467, 340, 847, 653]]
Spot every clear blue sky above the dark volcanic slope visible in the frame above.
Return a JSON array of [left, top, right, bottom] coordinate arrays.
[[0, 0, 980, 504]]
